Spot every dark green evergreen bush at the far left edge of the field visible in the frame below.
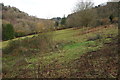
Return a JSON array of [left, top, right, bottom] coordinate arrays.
[[2, 24, 14, 40]]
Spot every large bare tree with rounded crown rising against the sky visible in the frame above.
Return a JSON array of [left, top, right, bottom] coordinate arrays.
[[67, 0, 97, 27]]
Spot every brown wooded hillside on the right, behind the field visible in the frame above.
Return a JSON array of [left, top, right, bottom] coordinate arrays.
[[66, 2, 119, 27]]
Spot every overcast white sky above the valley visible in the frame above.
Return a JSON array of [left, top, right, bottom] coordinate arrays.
[[0, 0, 108, 19]]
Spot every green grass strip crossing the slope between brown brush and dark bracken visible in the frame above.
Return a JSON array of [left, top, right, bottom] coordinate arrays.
[[3, 24, 118, 77]]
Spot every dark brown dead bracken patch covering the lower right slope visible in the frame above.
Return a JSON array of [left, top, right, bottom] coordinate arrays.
[[71, 37, 118, 78]]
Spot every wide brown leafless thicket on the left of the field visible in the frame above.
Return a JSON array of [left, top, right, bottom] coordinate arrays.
[[3, 33, 54, 54]]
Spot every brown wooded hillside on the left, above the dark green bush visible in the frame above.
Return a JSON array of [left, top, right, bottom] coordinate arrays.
[[2, 4, 54, 34]]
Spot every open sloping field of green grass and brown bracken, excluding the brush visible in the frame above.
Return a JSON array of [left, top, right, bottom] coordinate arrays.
[[2, 25, 118, 78]]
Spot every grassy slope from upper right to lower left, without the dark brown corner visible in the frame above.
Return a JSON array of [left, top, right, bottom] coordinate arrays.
[[3, 26, 118, 77]]
